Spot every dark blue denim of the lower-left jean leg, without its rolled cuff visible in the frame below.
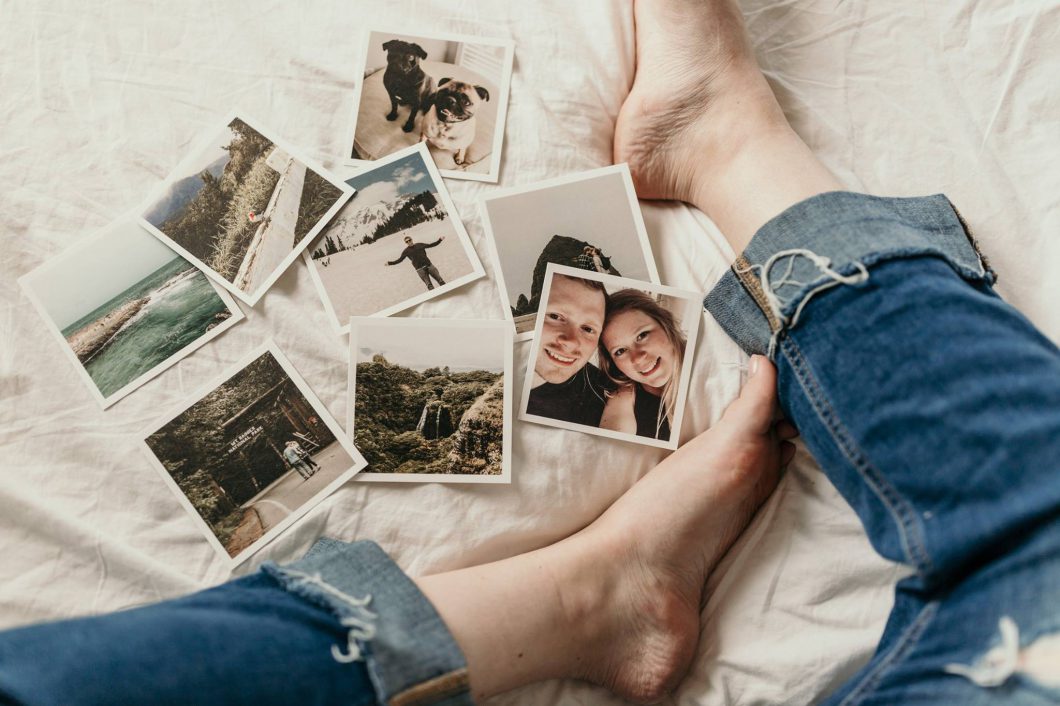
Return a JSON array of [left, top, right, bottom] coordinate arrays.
[[0, 573, 376, 706]]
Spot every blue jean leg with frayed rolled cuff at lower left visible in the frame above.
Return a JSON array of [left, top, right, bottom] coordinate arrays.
[[0, 540, 472, 706]]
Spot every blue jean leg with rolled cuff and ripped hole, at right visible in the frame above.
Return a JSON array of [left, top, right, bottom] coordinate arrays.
[[706, 194, 1060, 704]]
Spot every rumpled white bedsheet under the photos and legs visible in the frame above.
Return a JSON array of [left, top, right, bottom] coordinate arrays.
[[0, 0, 1060, 705]]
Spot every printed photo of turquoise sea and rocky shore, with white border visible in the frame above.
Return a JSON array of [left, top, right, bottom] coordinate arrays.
[[19, 219, 243, 408]]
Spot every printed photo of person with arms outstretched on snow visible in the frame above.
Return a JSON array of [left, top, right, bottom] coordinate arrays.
[[305, 144, 484, 333]]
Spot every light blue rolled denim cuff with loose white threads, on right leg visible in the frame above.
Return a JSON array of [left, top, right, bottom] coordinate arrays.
[[703, 192, 995, 357]]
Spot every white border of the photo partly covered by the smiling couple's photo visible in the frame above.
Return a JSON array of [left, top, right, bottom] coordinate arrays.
[[478, 162, 661, 341]]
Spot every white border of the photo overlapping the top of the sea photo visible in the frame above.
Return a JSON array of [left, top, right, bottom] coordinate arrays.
[[137, 110, 354, 306]]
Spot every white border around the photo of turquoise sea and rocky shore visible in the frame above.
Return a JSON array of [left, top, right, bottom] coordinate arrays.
[[18, 215, 246, 409]]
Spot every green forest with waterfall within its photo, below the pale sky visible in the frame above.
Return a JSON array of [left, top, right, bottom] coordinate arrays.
[[354, 354, 505, 475]]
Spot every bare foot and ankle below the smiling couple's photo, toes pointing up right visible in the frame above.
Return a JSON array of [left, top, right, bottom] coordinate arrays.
[[417, 356, 795, 702]]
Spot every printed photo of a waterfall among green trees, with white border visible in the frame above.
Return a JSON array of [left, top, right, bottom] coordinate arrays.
[[347, 318, 513, 483]]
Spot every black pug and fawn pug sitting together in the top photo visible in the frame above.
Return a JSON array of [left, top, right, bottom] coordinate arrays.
[[383, 39, 490, 167]]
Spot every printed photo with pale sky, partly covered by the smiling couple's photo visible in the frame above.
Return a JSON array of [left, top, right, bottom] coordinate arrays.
[[481, 164, 659, 340]]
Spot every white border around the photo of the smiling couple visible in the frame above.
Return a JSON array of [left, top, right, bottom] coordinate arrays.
[[519, 263, 703, 451]]
